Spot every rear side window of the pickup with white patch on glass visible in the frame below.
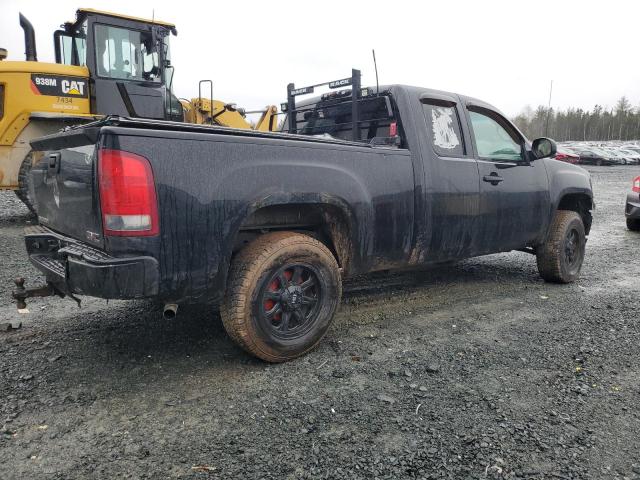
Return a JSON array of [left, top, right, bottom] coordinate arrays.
[[422, 103, 465, 157]]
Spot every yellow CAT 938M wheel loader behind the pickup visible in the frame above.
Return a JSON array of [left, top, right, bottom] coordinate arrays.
[[0, 8, 277, 211]]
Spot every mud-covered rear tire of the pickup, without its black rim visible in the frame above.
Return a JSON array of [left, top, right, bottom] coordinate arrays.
[[220, 232, 342, 362]]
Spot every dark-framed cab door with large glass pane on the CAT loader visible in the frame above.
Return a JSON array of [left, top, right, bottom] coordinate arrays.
[[88, 23, 166, 119]]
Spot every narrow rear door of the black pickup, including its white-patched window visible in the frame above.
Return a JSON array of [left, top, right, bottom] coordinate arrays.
[[419, 93, 479, 262]]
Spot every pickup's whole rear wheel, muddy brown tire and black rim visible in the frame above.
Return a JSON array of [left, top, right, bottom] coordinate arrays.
[[220, 232, 342, 362]]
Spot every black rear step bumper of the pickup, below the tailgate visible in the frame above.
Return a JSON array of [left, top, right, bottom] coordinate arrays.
[[25, 226, 159, 300]]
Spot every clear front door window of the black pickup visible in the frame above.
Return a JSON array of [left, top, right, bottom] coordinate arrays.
[[469, 110, 523, 162]]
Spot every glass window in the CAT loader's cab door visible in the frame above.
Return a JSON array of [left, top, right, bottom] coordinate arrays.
[[95, 25, 161, 82]]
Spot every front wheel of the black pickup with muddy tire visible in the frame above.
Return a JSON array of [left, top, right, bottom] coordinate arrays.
[[536, 210, 586, 283]]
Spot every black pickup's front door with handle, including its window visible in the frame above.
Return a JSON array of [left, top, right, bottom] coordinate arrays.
[[466, 105, 550, 253]]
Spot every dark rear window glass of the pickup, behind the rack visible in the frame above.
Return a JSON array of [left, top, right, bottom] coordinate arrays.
[[296, 97, 394, 142]]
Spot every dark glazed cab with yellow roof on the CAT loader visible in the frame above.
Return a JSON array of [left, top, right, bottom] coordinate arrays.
[[54, 9, 183, 121]]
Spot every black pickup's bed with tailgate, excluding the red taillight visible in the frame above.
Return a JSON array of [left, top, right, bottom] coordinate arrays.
[[32, 117, 415, 301]]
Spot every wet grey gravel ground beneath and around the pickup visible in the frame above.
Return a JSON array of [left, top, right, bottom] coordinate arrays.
[[0, 167, 640, 479]]
